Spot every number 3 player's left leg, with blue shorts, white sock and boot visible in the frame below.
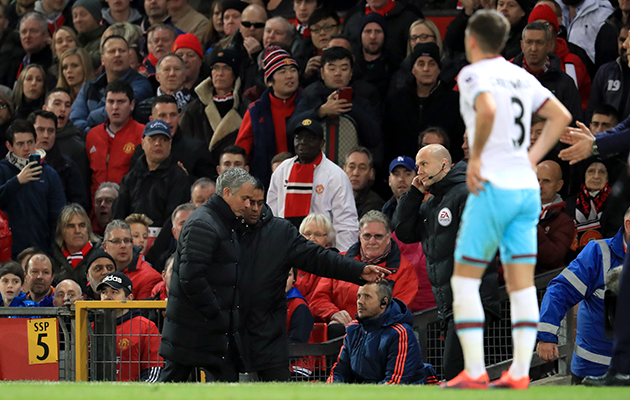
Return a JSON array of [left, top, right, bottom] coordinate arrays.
[[445, 185, 503, 388]]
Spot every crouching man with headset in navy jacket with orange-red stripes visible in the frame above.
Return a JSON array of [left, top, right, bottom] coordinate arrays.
[[328, 280, 437, 385]]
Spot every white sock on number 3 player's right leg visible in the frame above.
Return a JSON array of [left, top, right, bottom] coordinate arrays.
[[510, 286, 539, 379]]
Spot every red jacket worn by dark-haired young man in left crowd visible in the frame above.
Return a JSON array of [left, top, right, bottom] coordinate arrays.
[[85, 118, 144, 198]]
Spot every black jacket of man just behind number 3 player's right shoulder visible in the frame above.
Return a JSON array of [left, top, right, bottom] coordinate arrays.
[[512, 53, 582, 121]]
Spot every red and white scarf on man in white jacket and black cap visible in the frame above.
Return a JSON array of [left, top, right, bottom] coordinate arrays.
[[284, 152, 324, 222]]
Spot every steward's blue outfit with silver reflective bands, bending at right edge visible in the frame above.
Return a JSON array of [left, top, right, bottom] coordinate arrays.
[[538, 228, 628, 378]]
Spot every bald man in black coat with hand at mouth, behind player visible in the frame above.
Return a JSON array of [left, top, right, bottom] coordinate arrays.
[[394, 144, 500, 380]]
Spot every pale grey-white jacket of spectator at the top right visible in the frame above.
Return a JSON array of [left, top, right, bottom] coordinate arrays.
[[556, 0, 615, 62]]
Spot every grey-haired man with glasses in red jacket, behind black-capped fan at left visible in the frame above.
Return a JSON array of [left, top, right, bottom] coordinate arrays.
[[101, 219, 162, 300]]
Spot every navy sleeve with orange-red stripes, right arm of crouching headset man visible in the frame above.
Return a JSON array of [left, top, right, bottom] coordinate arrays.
[[379, 324, 422, 385]]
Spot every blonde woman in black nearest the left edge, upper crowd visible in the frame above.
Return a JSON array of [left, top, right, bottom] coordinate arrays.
[[13, 64, 46, 119]]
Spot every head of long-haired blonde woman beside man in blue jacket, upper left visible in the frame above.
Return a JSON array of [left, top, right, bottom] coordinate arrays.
[[57, 47, 94, 102]]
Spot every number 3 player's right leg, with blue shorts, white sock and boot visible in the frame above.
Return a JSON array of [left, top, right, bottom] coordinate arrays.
[[494, 190, 540, 389]]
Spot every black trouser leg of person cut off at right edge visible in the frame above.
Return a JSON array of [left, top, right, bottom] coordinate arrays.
[[611, 251, 630, 374]]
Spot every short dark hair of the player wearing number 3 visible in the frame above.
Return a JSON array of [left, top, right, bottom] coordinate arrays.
[[466, 10, 511, 54]]
